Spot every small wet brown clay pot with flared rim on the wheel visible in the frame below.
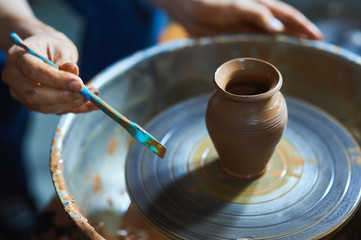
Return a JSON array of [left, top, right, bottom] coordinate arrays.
[[206, 58, 287, 179]]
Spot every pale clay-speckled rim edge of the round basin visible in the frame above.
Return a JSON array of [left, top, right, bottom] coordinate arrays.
[[50, 35, 361, 239]]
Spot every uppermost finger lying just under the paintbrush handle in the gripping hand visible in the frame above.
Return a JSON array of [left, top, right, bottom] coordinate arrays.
[[12, 47, 83, 92]]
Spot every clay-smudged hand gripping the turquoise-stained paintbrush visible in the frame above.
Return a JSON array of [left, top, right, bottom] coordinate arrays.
[[2, 29, 98, 114]]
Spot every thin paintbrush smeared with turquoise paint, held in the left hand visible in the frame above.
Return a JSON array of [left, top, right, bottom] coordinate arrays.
[[10, 33, 167, 158]]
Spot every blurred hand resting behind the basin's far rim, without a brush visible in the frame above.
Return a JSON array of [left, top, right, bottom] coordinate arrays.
[[150, 0, 322, 40]]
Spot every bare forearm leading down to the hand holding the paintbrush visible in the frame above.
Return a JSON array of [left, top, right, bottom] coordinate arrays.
[[0, 0, 53, 51]]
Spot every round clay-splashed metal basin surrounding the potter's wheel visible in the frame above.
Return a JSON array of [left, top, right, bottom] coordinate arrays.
[[50, 35, 361, 239]]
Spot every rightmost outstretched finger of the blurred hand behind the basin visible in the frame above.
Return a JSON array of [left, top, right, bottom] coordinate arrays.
[[260, 0, 323, 40]]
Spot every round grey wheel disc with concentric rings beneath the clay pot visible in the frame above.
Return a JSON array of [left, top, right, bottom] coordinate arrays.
[[126, 95, 361, 239]]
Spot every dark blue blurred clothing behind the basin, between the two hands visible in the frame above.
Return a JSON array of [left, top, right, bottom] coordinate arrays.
[[67, 0, 166, 81]]
